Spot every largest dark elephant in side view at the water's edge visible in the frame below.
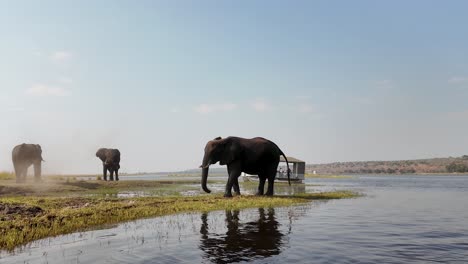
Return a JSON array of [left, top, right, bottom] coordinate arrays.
[[200, 137, 291, 197]]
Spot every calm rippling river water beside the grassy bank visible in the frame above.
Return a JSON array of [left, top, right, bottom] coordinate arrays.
[[0, 175, 468, 263]]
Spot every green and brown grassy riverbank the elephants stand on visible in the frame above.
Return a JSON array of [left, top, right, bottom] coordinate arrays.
[[0, 176, 357, 250]]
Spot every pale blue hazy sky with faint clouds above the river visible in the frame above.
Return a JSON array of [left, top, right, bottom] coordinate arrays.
[[0, 0, 468, 174]]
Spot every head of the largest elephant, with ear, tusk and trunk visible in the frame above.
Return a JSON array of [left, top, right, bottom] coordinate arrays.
[[200, 137, 239, 193]]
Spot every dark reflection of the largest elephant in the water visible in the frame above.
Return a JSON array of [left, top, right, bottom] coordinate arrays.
[[200, 208, 284, 263]]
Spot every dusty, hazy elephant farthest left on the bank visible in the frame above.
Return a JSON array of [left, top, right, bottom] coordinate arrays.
[[11, 143, 44, 182]]
